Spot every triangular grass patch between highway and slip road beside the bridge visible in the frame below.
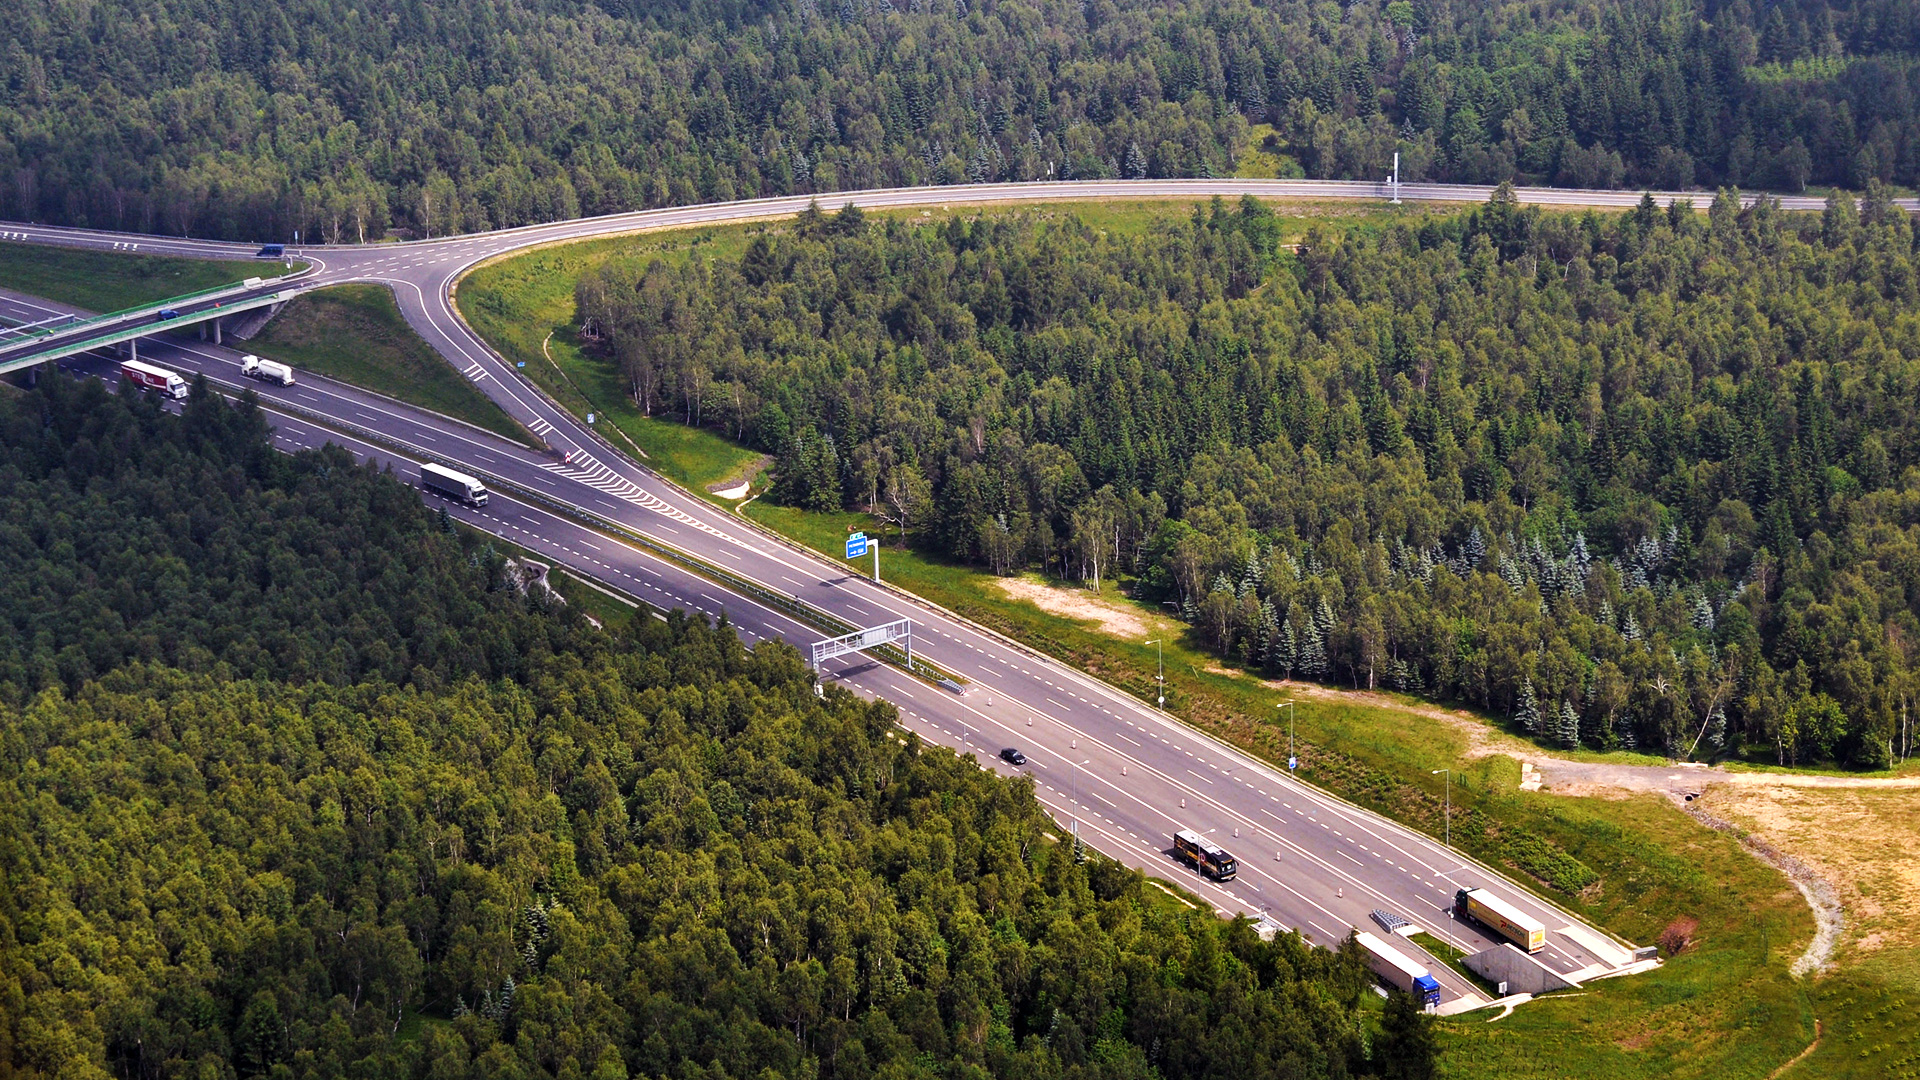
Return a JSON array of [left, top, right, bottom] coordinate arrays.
[[246, 284, 526, 442]]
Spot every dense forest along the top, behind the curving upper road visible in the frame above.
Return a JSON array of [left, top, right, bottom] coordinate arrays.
[[0, 0, 1920, 242]]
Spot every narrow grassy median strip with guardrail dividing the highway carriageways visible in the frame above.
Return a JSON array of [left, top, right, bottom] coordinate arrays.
[[236, 386, 966, 694]]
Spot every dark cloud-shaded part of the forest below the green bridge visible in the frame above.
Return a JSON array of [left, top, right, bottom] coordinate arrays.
[[0, 368, 570, 687]]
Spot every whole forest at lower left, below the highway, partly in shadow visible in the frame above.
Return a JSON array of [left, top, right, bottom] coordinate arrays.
[[0, 379, 1432, 1080]]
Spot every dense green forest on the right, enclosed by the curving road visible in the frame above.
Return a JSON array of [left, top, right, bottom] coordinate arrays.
[[576, 186, 1920, 765]]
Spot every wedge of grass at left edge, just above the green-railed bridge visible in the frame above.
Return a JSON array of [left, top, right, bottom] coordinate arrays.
[[0, 244, 301, 311]]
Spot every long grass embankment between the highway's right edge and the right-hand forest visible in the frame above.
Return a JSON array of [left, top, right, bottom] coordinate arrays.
[[461, 204, 1814, 1078]]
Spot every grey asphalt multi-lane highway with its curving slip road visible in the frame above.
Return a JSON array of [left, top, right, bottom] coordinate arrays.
[[0, 181, 1712, 999]]
